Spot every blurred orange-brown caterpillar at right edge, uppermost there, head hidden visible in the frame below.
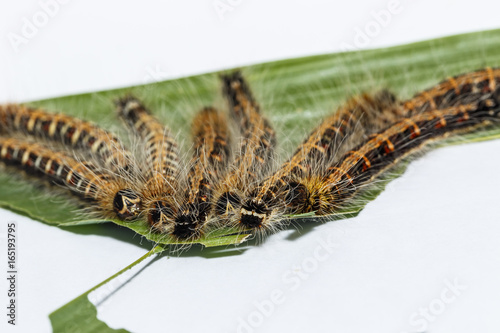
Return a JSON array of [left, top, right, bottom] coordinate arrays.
[[404, 67, 500, 114]]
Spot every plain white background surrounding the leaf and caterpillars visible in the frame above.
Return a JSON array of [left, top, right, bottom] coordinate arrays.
[[0, 0, 500, 332]]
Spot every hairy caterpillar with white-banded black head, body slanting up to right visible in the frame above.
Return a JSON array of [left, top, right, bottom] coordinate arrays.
[[236, 90, 405, 228]]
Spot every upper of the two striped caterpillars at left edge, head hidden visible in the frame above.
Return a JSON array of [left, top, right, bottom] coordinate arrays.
[[0, 104, 131, 172]]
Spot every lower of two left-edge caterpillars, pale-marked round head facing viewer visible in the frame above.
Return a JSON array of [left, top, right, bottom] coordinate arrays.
[[0, 137, 142, 221]]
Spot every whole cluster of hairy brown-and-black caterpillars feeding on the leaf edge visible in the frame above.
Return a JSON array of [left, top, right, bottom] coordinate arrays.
[[0, 68, 500, 241]]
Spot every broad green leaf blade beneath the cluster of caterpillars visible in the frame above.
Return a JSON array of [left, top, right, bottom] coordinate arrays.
[[0, 30, 500, 246]]
